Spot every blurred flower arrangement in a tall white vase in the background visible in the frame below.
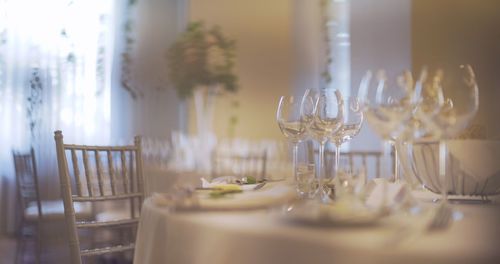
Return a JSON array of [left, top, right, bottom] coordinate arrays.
[[167, 22, 238, 172]]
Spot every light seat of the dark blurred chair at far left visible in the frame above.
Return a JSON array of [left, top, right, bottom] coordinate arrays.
[[24, 200, 92, 221]]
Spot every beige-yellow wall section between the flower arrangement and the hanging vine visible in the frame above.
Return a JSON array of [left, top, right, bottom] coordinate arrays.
[[190, 0, 293, 139]]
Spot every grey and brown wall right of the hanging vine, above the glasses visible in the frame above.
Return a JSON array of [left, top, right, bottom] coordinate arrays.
[[350, 0, 500, 146]]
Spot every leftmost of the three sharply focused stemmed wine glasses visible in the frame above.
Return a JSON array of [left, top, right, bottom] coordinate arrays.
[[276, 96, 307, 189]]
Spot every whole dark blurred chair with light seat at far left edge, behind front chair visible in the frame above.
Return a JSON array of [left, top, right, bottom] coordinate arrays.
[[12, 148, 91, 263]]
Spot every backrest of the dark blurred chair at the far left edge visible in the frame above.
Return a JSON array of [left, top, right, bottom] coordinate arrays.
[[12, 148, 43, 220]]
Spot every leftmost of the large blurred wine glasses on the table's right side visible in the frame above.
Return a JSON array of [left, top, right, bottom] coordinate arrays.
[[358, 70, 416, 182]]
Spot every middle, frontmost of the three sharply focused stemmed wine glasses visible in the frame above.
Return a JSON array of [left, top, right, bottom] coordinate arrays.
[[301, 89, 344, 203]]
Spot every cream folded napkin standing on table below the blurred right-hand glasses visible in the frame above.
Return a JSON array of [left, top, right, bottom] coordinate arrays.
[[365, 178, 415, 210]]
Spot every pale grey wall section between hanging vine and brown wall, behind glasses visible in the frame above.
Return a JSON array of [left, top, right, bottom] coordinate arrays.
[[350, 0, 412, 150]]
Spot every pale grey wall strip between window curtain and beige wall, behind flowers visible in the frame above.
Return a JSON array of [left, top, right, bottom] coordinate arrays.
[[111, 0, 188, 142]]
